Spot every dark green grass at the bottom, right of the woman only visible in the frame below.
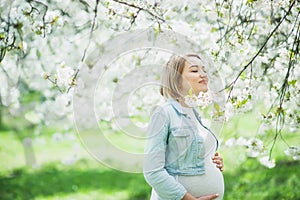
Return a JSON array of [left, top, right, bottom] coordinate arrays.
[[224, 159, 300, 200]]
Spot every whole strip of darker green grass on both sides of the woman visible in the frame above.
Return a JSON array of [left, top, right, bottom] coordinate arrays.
[[0, 155, 300, 200]]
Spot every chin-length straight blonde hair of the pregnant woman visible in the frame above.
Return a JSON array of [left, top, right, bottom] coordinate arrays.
[[160, 54, 201, 99]]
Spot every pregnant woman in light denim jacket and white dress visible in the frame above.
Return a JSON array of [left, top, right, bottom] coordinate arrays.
[[144, 54, 224, 200]]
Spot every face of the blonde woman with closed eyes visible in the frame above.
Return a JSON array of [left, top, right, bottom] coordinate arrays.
[[181, 57, 208, 95]]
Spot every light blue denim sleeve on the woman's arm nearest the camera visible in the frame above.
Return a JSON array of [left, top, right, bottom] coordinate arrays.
[[143, 109, 187, 200]]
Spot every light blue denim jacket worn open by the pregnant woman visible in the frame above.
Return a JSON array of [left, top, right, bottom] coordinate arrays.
[[144, 99, 218, 200]]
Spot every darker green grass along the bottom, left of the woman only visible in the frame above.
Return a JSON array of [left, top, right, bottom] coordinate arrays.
[[0, 160, 150, 199]]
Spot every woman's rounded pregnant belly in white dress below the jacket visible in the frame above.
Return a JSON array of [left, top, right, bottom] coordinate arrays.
[[178, 158, 224, 199]]
